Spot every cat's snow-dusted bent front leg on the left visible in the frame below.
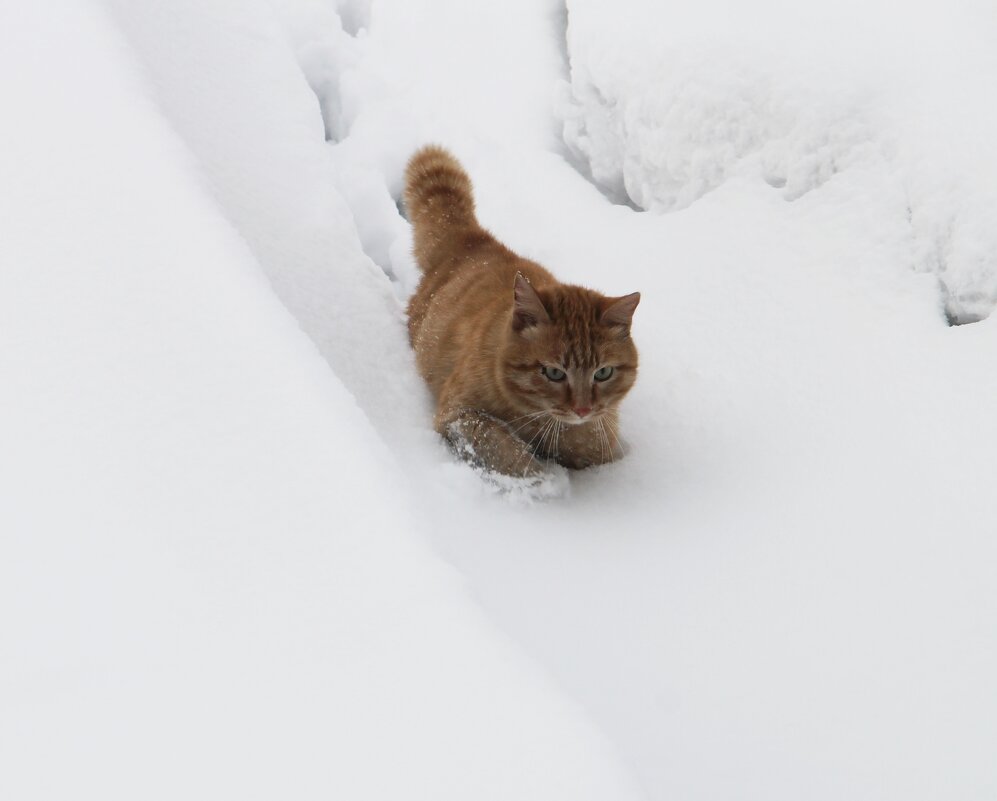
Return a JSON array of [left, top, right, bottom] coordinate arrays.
[[436, 406, 543, 476]]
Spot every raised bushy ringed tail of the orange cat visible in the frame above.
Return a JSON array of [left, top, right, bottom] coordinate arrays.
[[405, 145, 478, 270]]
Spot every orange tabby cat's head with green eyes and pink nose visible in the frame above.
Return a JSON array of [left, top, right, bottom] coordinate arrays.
[[502, 274, 640, 424]]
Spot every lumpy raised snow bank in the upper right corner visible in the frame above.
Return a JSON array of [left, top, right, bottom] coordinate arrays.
[[559, 0, 997, 322]]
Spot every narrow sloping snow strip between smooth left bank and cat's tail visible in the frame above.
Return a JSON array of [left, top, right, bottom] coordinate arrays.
[[106, 0, 426, 444]]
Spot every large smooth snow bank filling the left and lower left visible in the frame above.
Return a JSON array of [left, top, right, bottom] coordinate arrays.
[[0, 3, 634, 799]]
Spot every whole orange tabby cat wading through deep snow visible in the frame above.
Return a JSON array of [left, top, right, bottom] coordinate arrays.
[[405, 146, 640, 477]]
